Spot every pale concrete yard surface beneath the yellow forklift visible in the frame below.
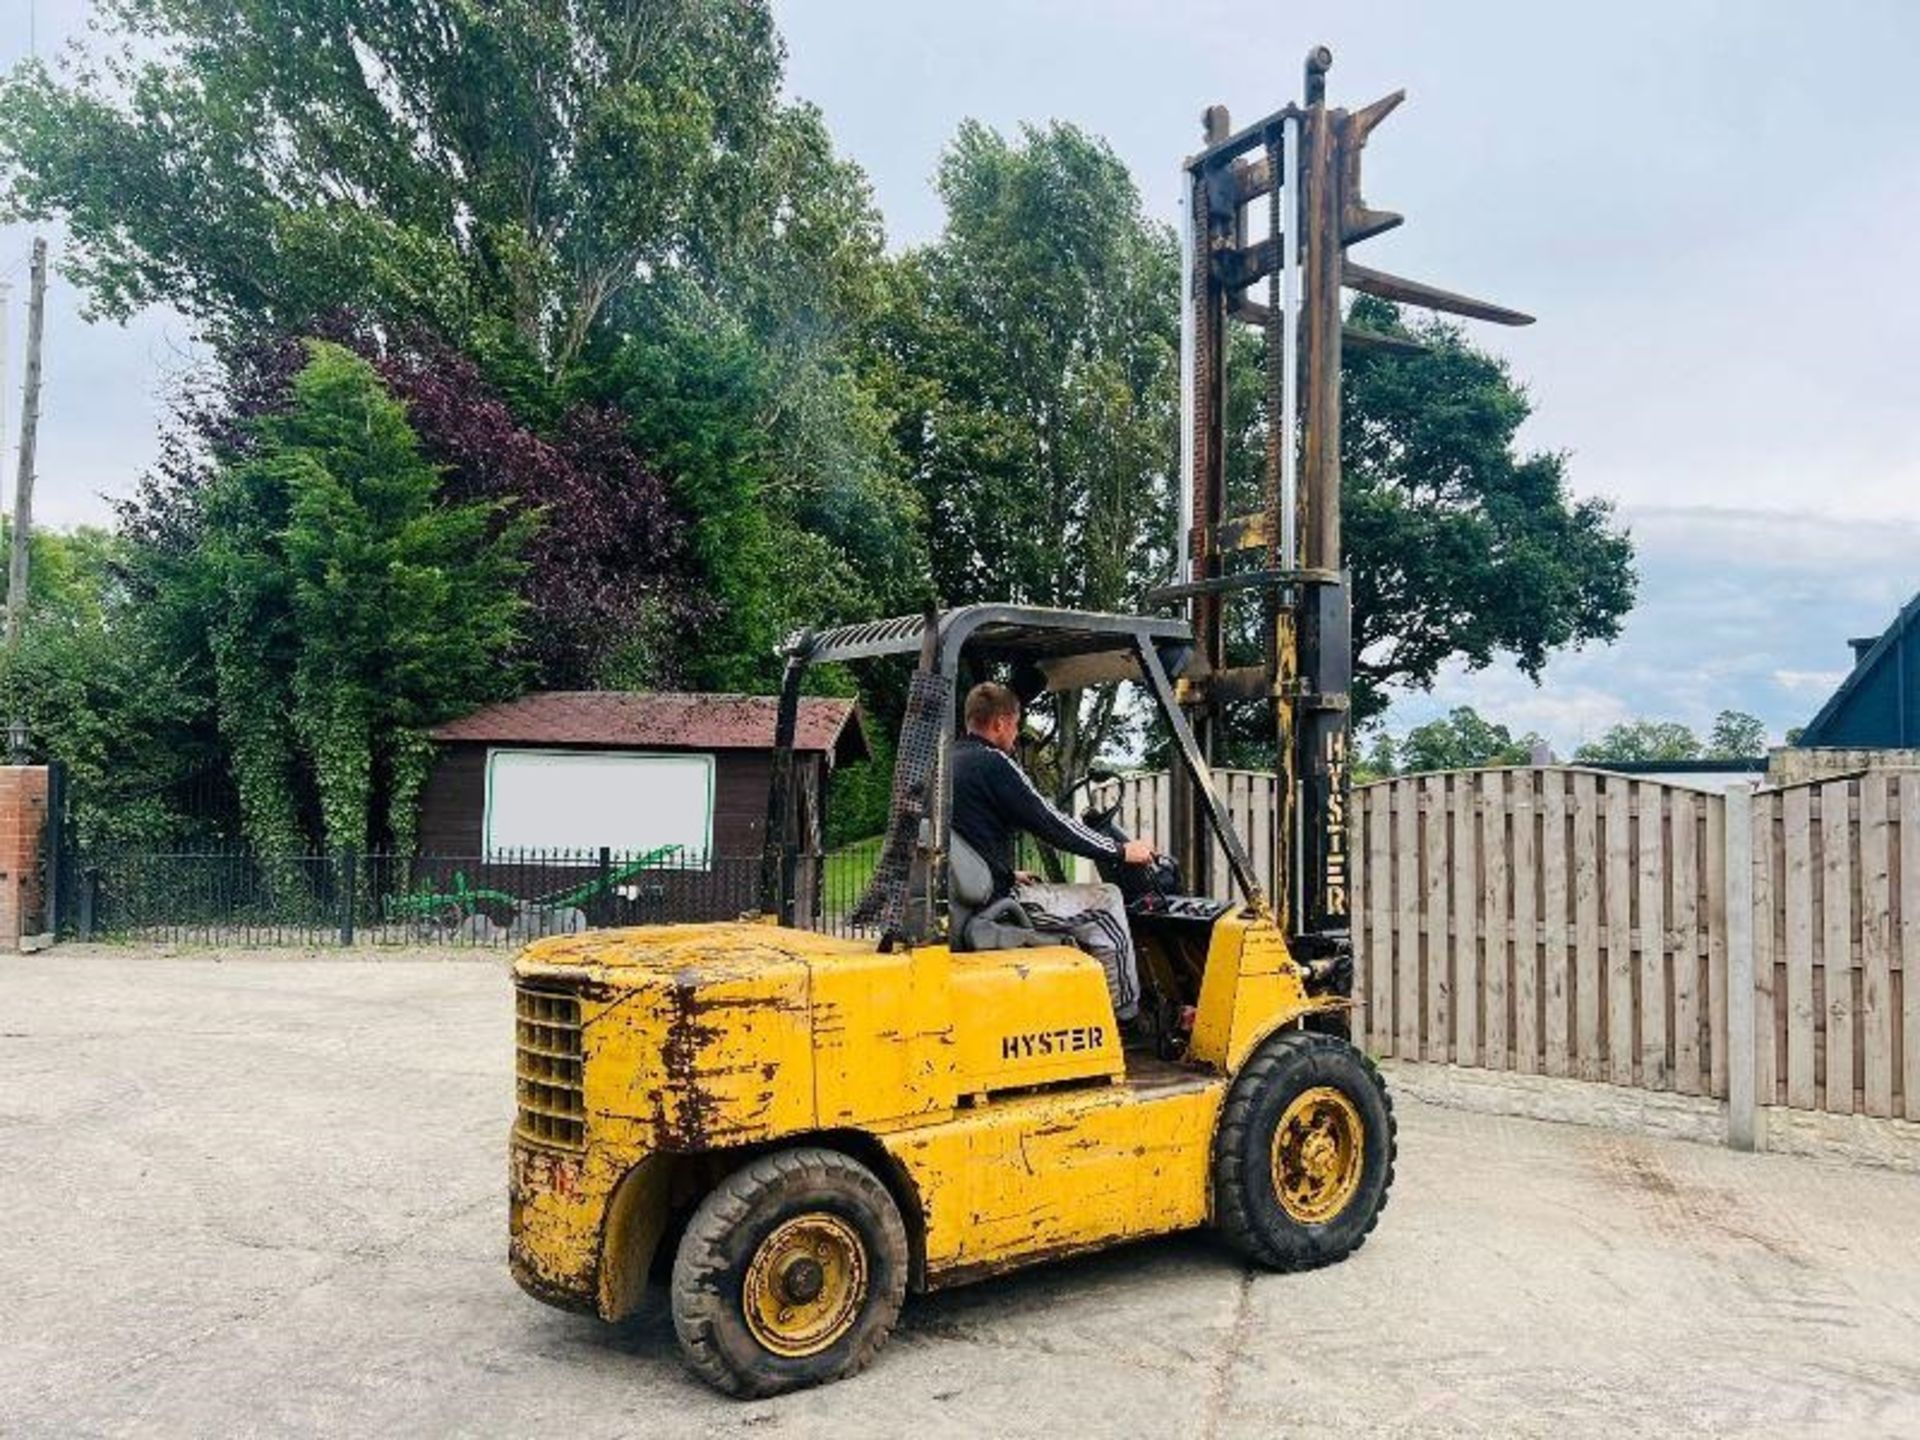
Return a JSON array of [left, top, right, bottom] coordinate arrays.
[[11, 950, 1920, 1440]]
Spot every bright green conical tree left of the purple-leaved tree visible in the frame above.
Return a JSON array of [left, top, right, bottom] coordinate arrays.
[[185, 342, 530, 854]]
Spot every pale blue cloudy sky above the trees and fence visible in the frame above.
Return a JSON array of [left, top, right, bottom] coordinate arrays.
[[0, 0, 1920, 753]]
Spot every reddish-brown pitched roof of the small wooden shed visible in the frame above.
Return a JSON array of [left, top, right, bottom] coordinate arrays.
[[434, 689, 868, 764]]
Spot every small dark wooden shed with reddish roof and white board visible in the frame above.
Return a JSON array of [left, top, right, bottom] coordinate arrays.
[[419, 691, 868, 920]]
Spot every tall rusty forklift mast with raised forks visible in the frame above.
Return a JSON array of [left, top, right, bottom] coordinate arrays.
[[1150, 46, 1532, 960]]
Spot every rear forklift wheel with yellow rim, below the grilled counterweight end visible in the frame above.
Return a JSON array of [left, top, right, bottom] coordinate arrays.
[[672, 1148, 908, 1398]]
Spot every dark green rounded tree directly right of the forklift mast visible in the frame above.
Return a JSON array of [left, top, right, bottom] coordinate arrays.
[[1336, 298, 1634, 720]]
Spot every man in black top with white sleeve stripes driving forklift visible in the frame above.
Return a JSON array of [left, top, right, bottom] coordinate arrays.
[[952, 682, 1154, 1031]]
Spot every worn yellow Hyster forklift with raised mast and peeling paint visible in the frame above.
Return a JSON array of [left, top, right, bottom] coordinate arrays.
[[511, 50, 1524, 1396]]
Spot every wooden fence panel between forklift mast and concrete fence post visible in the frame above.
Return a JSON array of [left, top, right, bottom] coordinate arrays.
[[1354, 768, 1728, 1096]]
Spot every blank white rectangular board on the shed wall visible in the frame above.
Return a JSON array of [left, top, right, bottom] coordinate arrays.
[[484, 749, 714, 864]]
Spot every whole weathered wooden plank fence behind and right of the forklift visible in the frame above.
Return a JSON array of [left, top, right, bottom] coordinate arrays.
[[1123, 766, 1920, 1133]]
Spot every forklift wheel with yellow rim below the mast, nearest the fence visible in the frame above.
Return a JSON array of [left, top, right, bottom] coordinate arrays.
[[1213, 1031, 1394, 1269]]
